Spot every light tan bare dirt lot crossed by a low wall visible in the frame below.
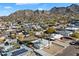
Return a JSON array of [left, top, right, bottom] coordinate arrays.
[[43, 39, 72, 55]]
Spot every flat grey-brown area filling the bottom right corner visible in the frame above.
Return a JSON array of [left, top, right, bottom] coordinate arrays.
[[56, 45, 79, 56]]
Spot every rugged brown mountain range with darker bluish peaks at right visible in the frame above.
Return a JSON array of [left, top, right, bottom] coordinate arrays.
[[0, 4, 79, 22]]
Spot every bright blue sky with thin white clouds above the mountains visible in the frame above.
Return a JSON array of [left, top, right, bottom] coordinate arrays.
[[0, 3, 71, 16]]
